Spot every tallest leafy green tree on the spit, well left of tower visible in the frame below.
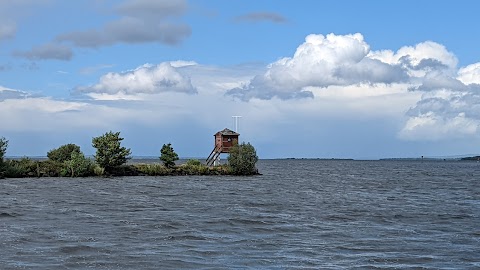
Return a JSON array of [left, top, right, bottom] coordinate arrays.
[[92, 131, 131, 173]]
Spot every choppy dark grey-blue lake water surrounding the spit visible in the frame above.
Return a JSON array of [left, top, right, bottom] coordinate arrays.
[[0, 160, 480, 269]]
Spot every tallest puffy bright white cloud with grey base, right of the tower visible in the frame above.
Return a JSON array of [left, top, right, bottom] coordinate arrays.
[[227, 33, 407, 100]]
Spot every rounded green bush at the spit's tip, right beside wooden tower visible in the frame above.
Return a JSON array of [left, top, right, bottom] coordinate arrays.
[[228, 142, 258, 175]]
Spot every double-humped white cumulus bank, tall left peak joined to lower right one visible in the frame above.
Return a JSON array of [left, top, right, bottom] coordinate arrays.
[[227, 33, 464, 101]]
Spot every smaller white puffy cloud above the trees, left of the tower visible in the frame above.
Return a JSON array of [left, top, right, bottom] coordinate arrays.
[[76, 62, 197, 99]]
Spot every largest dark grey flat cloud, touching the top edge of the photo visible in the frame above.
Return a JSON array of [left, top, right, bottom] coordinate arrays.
[[56, 0, 191, 47]]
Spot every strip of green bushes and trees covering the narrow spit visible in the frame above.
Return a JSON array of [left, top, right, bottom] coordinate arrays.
[[0, 131, 258, 178]]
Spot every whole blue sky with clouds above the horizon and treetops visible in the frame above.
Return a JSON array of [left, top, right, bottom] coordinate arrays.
[[0, 0, 480, 159]]
